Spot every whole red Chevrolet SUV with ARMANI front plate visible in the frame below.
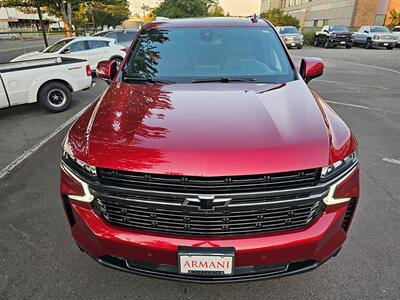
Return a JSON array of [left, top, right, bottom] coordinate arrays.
[[61, 18, 359, 282]]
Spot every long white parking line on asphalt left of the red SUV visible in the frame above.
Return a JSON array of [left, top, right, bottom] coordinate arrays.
[[0, 104, 90, 180]]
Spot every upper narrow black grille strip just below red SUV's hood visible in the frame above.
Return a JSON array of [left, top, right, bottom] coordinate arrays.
[[97, 168, 320, 194]]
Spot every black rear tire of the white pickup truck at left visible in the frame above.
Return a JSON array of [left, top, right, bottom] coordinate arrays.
[[38, 81, 72, 113]]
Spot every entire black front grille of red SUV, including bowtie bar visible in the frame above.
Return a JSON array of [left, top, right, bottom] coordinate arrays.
[[89, 168, 328, 236]]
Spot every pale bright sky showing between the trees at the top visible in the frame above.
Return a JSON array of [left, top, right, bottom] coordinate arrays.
[[130, 0, 261, 16]]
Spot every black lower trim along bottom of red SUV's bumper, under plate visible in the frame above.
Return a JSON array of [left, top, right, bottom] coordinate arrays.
[[95, 256, 321, 283]]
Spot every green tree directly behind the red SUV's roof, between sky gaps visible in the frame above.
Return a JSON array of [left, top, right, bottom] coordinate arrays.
[[154, 0, 218, 18]]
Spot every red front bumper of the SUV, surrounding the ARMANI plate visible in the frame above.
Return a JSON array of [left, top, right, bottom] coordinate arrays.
[[66, 200, 356, 282]]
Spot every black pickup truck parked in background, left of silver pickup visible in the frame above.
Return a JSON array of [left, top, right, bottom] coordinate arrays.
[[314, 25, 353, 49]]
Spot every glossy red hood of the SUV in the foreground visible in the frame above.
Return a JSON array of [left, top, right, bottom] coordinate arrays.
[[66, 80, 330, 176]]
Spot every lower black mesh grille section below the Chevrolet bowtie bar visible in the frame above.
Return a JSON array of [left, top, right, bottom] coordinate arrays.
[[94, 198, 324, 236]]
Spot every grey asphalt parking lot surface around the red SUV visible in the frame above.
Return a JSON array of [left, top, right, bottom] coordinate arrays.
[[0, 47, 400, 299]]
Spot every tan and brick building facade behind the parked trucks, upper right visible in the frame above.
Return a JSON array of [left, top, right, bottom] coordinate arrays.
[[261, 0, 400, 28]]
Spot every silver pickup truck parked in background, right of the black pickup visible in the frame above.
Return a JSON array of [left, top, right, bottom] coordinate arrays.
[[353, 26, 397, 50]]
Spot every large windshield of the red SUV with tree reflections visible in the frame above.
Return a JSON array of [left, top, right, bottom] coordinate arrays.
[[123, 27, 295, 83]]
